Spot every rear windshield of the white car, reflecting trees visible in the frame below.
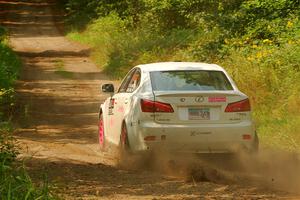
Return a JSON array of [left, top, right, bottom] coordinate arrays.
[[150, 70, 233, 91]]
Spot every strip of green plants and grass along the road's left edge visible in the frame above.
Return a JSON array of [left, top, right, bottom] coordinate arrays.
[[0, 26, 54, 200]]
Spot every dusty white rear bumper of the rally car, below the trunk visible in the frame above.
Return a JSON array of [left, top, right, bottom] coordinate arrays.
[[132, 121, 255, 153]]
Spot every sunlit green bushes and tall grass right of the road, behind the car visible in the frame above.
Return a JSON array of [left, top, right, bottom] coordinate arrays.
[[66, 0, 300, 151]]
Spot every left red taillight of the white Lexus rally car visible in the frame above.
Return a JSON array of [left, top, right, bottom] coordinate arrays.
[[141, 99, 174, 112]]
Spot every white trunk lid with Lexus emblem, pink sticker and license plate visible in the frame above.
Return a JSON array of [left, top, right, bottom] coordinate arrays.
[[154, 91, 248, 124]]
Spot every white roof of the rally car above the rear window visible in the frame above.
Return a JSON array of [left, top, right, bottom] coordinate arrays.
[[137, 62, 224, 71]]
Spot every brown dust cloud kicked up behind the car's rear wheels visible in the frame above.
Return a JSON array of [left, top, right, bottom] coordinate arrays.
[[118, 149, 300, 194]]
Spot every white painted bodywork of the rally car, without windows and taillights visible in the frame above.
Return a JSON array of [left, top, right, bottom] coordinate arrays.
[[100, 62, 255, 153]]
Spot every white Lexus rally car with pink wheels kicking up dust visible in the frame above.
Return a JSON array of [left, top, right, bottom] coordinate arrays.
[[99, 62, 258, 153]]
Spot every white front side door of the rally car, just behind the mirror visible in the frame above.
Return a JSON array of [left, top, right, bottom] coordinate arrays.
[[108, 69, 135, 144]]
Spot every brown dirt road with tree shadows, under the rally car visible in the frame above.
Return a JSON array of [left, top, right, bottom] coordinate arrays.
[[0, 0, 300, 199]]
